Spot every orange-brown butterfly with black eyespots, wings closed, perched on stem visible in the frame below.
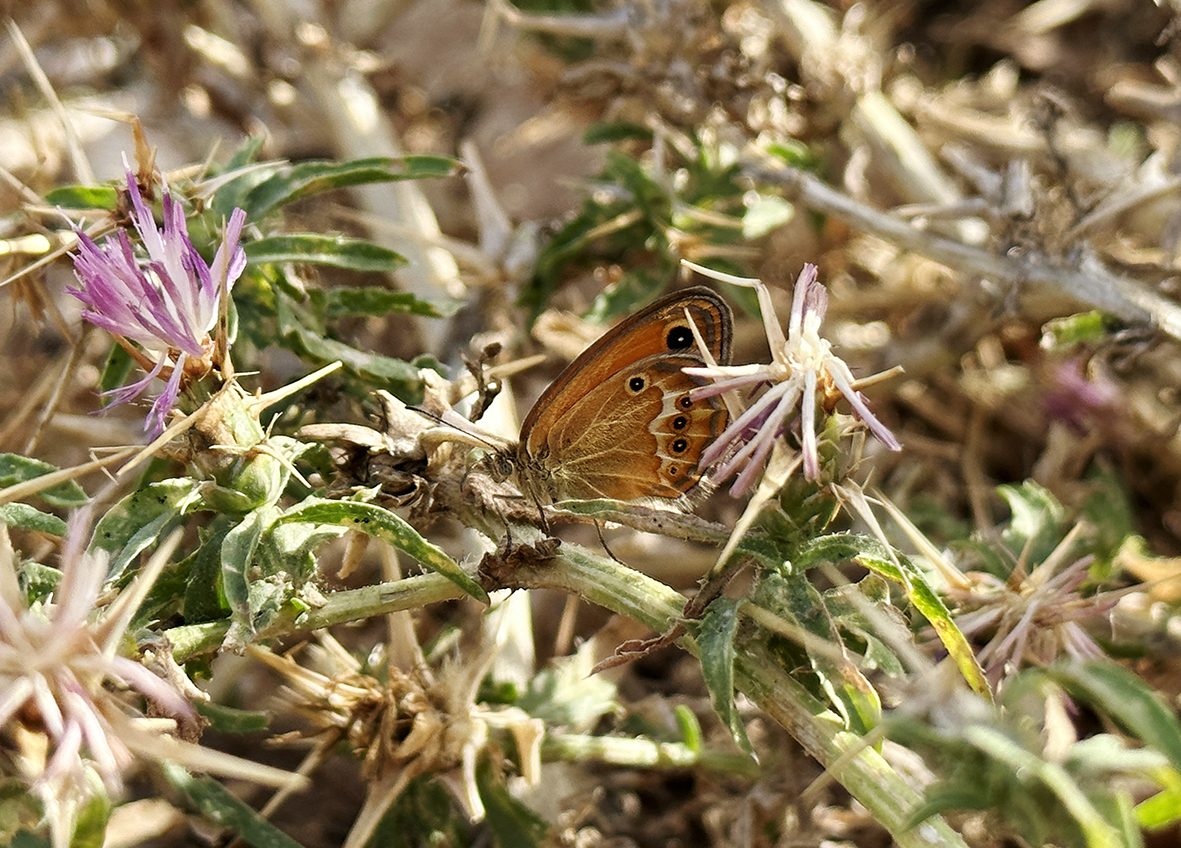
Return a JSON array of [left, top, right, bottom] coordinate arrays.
[[503, 286, 733, 503]]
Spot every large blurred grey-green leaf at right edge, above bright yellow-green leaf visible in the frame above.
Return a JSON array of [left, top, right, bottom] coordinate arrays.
[[1045, 661, 1181, 771]]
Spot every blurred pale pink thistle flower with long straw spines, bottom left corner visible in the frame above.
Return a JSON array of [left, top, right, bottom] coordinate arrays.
[[0, 513, 304, 848]]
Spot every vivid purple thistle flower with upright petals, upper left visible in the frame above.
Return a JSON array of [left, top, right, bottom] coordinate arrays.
[[68, 170, 246, 437]]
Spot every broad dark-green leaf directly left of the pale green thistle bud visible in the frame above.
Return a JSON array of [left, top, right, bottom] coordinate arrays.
[[91, 477, 201, 580]]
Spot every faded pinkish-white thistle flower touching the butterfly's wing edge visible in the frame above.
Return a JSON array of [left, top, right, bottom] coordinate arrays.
[[685, 262, 901, 495]]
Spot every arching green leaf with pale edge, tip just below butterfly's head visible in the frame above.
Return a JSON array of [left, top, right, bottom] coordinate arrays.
[[279, 497, 488, 604]]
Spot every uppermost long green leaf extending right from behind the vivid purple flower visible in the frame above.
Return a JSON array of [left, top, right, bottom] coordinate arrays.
[[244, 156, 463, 220]]
